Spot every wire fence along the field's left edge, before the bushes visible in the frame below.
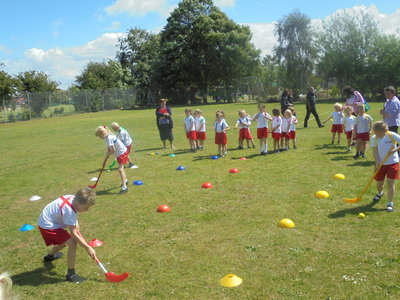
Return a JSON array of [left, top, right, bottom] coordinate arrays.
[[0, 87, 140, 123]]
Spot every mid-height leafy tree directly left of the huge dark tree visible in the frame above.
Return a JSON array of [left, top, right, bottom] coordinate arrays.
[[117, 28, 160, 104]]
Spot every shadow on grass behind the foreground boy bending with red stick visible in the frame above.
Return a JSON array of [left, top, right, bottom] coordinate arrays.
[[11, 263, 65, 286]]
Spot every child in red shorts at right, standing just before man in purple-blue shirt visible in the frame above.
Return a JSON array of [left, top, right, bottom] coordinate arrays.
[[353, 103, 374, 159]]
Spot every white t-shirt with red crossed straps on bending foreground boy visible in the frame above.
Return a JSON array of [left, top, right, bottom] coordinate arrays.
[[38, 195, 76, 229]]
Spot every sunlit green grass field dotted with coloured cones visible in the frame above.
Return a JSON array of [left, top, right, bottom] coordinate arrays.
[[0, 104, 400, 299]]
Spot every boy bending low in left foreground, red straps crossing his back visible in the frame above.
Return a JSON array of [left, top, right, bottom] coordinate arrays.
[[38, 188, 96, 283]]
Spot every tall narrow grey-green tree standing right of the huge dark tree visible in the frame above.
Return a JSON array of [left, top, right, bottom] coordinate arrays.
[[274, 11, 317, 89]]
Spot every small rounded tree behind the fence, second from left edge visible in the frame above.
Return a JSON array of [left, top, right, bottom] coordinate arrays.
[[17, 70, 59, 117]]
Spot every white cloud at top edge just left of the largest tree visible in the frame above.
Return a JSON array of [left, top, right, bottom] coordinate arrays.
[[105, 0, 173, 16]]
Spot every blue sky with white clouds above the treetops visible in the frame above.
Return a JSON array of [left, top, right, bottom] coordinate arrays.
[[0, 0, 400, 88]]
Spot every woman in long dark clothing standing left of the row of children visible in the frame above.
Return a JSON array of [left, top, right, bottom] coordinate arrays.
[[156, 99, 175, 149]]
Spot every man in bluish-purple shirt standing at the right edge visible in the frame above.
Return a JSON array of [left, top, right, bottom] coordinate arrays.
[[381, 86, 400, 133]]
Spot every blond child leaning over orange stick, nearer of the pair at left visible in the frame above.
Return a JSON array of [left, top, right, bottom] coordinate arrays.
[[95, 126, 128, 194]]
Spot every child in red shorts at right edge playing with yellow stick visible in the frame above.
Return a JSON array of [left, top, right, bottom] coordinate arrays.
[[371, 121, 400, 212]]
